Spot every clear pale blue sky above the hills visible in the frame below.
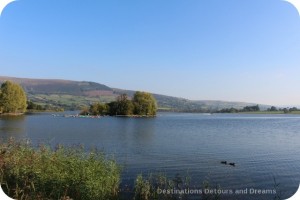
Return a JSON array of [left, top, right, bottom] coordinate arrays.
[[0, 0, 300, 106]]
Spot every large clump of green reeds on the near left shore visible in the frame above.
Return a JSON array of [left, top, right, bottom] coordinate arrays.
[[0, 140, 120, 200]]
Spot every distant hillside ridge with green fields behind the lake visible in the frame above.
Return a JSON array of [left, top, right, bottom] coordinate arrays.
[[0, 76, 269, 112]]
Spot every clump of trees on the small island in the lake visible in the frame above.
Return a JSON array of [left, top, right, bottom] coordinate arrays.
[[80, 91, 157, 116]]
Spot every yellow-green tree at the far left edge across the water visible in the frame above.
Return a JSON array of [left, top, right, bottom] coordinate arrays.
[[0, 81, 27, 113]]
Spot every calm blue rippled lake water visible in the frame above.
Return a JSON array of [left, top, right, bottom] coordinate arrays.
[[0, 113, 300, 199]]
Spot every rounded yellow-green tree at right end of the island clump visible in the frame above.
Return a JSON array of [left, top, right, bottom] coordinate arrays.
[[132, 92, 157, 116]]
